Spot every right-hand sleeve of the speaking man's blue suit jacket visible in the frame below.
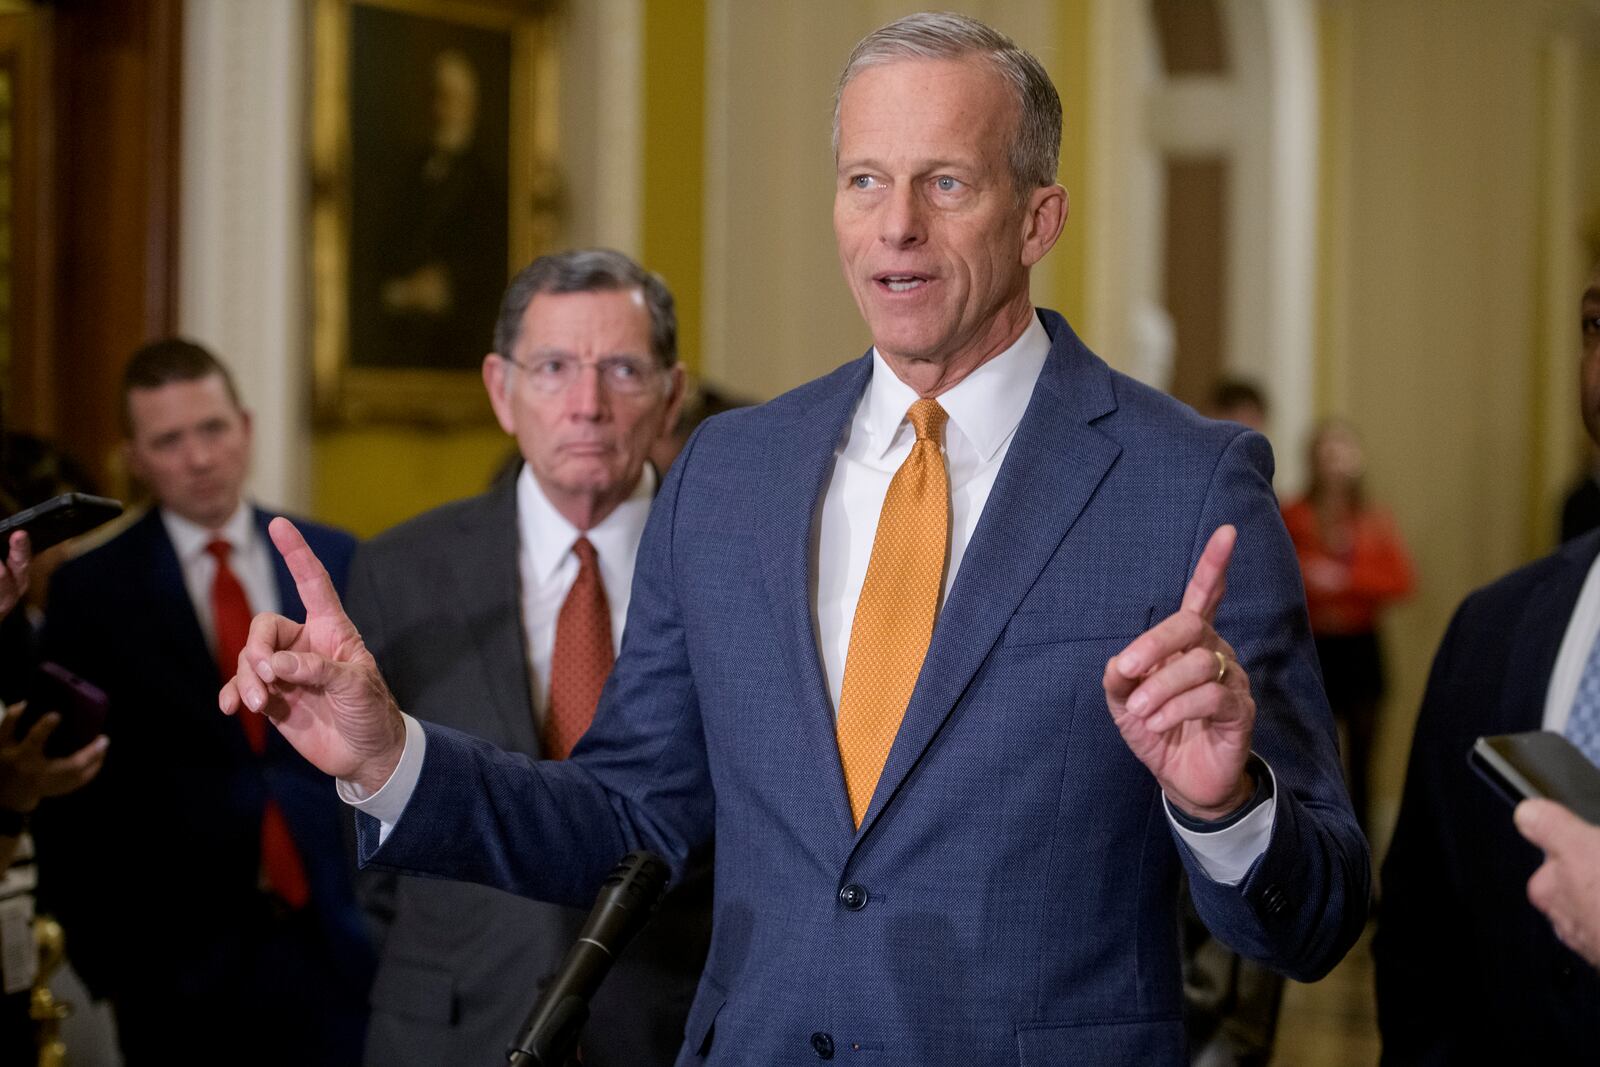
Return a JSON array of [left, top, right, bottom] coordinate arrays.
[[1179, 432, 1371, 981]]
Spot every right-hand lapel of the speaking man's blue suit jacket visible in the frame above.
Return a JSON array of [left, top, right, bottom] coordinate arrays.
[[858, 312, 1120, 840]]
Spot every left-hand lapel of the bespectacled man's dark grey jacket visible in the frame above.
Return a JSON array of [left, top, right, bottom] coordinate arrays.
[[438, 478, 541, 757]]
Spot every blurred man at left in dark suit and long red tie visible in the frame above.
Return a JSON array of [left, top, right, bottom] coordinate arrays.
[[38, 338, 373, 1067]]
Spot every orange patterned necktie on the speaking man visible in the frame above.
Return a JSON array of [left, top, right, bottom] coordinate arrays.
[[838, 398, 950, 827]]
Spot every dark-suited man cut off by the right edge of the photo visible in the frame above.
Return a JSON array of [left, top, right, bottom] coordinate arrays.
[[1373, 267, 1600, 1064]]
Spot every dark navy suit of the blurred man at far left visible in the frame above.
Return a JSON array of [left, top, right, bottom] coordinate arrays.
[[38, 510, 371, 1065]]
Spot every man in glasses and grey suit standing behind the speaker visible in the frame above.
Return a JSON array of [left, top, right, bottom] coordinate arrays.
[[347, 250, 710, 1067]]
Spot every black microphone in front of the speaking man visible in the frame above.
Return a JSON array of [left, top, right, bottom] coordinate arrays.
[[506, 851, 669, 1067]]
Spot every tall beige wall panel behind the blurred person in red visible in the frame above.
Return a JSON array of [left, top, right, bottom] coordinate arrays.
[[1331, 0, 1542, 843]]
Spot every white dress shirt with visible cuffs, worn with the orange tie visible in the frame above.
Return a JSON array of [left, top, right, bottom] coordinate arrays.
[[339, 315, 1277, 885]]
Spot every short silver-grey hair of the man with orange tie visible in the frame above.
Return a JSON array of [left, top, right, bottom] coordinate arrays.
[[834, 11, 1061, 195]]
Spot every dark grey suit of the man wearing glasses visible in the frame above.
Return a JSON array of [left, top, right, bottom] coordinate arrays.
[[347, 477, 710, 1067]]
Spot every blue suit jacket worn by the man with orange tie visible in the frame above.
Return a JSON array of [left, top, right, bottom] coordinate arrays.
[[362, 312, 1368, 1065]]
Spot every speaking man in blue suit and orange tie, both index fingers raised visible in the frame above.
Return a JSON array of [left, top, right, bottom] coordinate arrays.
[[219, 14, 1368, 1064]]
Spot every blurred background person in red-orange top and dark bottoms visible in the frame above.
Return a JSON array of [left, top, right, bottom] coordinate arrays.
[[1283, 419, 1414, 832]]
